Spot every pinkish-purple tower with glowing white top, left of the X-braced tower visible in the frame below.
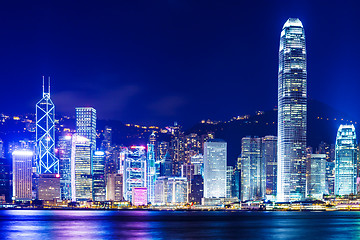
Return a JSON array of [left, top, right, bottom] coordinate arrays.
[[12, 150, 34, 201]]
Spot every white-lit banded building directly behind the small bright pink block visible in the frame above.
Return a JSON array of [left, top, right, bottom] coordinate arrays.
[[123, 146, 147, 201]]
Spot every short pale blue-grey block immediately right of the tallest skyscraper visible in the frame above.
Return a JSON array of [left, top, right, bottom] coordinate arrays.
[[307, 154, 326, 199]]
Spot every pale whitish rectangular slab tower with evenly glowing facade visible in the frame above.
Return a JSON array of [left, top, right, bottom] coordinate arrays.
[[204, 139, 227, 198]]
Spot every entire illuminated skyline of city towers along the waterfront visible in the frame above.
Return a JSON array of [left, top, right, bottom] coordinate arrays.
[[0, 18, 360, 206]]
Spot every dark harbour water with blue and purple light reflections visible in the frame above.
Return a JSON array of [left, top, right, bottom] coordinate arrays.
[[0, 210, 360, 240]]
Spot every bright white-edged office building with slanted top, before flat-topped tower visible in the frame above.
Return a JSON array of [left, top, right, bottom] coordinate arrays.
[[71, 134, 92, 201]]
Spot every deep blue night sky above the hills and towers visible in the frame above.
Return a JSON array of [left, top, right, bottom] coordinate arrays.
[[0, 0, 360, 126]]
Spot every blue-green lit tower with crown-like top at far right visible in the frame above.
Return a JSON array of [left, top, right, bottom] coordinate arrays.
[[335, 125, 358, 195]]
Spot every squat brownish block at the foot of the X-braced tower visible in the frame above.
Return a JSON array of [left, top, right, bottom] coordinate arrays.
[[38, 173, 61, 201]]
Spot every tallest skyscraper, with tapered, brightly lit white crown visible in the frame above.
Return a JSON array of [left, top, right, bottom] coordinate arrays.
[[277, 18, 307, 202]]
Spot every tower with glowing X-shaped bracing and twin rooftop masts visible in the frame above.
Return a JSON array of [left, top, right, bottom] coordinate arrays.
[[36, 77, 59, 174]]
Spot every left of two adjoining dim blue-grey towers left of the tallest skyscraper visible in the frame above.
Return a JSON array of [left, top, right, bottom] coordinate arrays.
[[241, 137, 266, 201]]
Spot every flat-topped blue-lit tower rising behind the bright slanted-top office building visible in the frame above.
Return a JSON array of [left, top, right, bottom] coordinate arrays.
[[76, 107, 96, 150]]
